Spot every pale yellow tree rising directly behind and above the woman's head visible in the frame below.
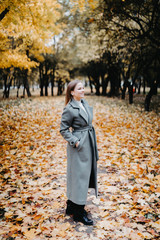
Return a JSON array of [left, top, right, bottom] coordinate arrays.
[[53, 1, 105, 95]]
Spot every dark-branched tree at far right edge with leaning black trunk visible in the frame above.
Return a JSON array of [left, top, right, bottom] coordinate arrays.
[[101, 0, 160, 110]]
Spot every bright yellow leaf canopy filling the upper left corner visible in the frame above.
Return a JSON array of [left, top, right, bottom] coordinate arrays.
[[0, 0, 61, 68]]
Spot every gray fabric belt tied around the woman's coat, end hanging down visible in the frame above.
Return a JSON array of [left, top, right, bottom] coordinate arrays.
[[73, 125, 99, 161]]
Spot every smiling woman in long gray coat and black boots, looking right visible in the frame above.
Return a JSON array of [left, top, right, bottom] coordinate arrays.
[[60, 80, 98, 225]]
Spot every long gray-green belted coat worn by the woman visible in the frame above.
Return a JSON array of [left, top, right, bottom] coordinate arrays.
[[60, 99, 98, 205]]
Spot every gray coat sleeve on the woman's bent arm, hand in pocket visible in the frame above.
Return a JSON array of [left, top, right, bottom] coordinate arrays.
[[60, 108, 79, 147]]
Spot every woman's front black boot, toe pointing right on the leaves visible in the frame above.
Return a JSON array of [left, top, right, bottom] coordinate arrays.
[[73, 204, 93, 225]]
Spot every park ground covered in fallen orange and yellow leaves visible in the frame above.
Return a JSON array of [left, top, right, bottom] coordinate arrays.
[[0, 96, 160, 240]]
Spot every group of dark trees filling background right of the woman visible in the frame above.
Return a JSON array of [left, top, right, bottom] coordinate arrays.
[[75, 0, 160, 111]]
